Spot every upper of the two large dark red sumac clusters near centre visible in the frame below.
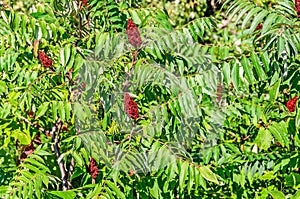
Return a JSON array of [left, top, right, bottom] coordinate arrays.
[[125, 19, 142, 48]]
